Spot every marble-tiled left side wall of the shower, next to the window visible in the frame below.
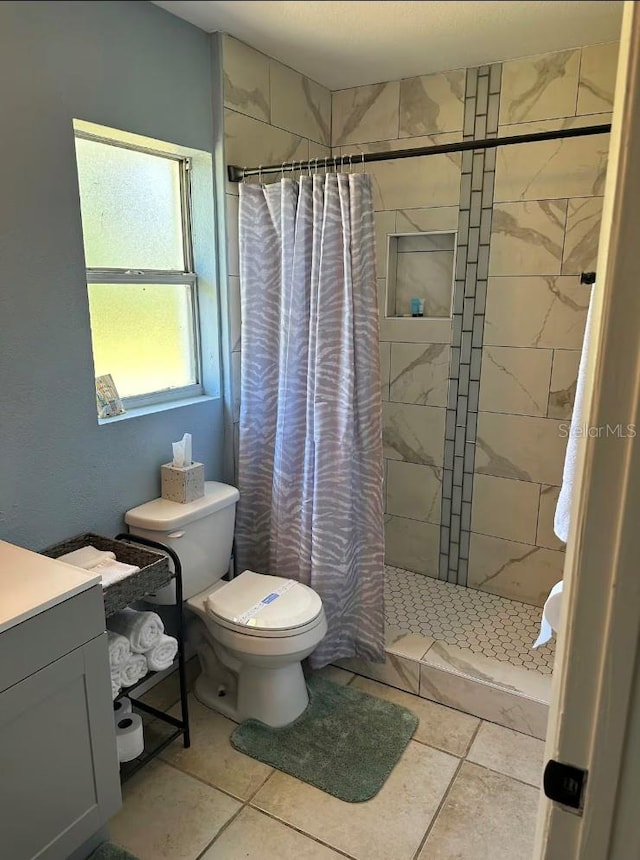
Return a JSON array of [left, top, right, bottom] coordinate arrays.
[[222, 35, 331, 478]]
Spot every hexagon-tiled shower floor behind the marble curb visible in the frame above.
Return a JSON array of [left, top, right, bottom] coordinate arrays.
[[385, 567, 555, 675]]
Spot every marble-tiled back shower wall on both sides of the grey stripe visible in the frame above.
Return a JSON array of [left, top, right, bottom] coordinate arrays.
[[332, 44, 617, 605]]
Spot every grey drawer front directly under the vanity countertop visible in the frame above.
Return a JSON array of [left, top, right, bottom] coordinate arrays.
[[0, 585, 106, 692]]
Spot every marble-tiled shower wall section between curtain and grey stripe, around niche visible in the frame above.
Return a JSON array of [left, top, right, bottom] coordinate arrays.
[[332, 70, 465, 576]]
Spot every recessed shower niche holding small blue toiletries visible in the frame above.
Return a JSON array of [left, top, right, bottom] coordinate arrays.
[[386, 232, 456, 319]]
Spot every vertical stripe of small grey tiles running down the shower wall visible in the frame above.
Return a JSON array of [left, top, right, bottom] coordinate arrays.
[[438, 63, 502, 585]]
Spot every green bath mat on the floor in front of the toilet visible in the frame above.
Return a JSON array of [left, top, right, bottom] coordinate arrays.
[[231, 678, 418, 803]]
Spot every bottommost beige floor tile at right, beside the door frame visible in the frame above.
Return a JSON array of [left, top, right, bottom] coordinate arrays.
[[418, 763, 538, 860]]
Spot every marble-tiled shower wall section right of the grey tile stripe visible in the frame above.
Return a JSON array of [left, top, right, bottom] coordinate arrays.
[[468, 44, 617, 604]]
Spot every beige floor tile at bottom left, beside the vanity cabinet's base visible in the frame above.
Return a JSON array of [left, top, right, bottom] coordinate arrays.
[[109, 761, 241, 860]]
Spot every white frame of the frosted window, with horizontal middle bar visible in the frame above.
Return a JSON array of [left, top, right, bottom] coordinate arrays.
[[74, 129, 204, 410]]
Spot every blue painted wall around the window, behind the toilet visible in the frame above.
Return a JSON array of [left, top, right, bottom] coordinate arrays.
[[0, 2, 228, 549]]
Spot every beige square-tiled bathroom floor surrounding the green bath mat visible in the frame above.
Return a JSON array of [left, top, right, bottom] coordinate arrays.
[[110, 667, 543, 860]]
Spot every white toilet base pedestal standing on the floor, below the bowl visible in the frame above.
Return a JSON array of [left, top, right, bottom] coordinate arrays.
[[195, 660, 309, 728]]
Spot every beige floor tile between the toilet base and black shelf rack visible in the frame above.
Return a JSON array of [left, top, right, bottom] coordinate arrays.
[[162, 696, 271, 800]]
